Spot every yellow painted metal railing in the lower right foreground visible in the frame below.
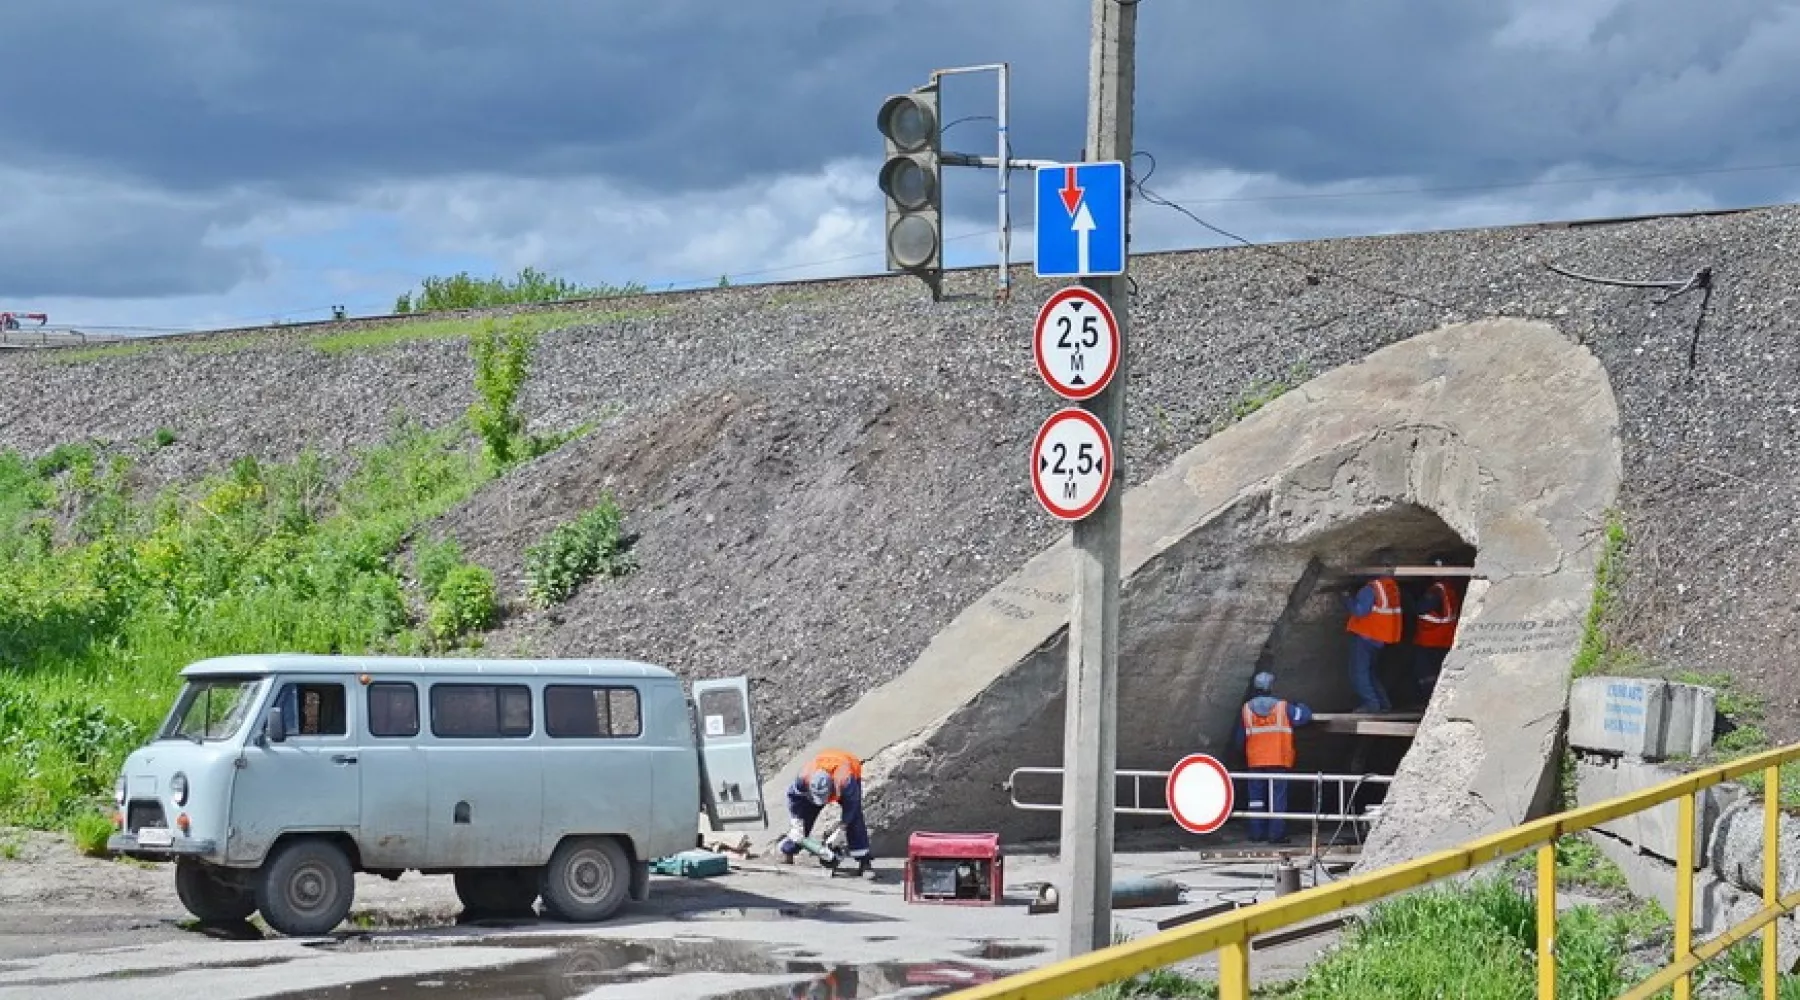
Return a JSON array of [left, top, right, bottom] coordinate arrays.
[[954, 745, 1800, 1000]]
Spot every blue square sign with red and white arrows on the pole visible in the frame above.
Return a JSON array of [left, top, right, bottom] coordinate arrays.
[[1037, 160, 1125, 277]]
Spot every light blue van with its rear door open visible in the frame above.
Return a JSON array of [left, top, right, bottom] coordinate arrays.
[[108, 653, 767, 935]]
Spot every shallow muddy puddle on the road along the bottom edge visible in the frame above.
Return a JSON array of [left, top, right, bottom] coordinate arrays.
[[264, 937, 1001, 1000]]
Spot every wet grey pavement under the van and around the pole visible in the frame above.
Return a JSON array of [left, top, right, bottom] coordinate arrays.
[[0, 838, 1353, 1000]]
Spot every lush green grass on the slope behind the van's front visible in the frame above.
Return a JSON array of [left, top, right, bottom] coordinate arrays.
[[0, 415, 493, 833]]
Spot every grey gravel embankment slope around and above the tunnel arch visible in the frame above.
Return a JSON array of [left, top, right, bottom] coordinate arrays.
[[0, 207, 1800, 773]]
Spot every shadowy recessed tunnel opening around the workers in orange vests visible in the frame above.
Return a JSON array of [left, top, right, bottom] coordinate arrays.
[[1004, 496, 1476, 849]]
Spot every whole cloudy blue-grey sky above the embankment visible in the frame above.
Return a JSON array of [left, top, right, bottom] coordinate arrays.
[[0, 0, 1800, 329]]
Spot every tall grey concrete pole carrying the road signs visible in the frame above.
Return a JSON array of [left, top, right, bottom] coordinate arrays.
[[1058, 0, 1138, 959]]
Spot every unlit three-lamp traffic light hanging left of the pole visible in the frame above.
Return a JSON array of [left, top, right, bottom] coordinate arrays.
[[875, 83, 943, 300]]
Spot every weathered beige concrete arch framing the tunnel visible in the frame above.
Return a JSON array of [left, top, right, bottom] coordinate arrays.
[[763, 318, 1624, 865]]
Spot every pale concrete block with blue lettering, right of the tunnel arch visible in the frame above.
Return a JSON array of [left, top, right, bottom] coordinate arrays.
[[1570, 676, 1717, 761]]
